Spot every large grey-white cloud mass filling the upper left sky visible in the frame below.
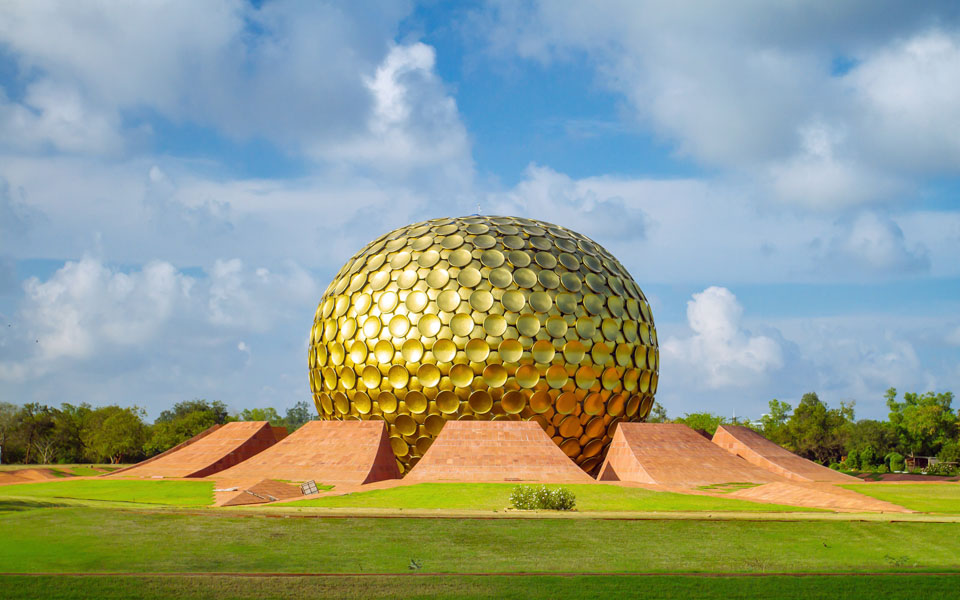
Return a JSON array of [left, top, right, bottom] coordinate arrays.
[[0, 0, 470, 171]]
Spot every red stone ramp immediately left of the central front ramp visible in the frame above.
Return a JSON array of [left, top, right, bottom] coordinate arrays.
[[217, 421, 400, 484]]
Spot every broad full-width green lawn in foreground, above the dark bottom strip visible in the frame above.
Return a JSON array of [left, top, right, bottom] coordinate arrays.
[[0, 507, 960, 574]]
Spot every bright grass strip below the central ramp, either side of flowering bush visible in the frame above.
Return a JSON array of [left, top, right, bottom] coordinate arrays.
[[283, 483, 817, 512]]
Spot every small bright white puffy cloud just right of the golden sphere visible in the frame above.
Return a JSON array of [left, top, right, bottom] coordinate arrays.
[[661, 286, 784, 389]]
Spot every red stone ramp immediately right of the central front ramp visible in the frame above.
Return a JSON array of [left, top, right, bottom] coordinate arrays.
[[599, 423, 784, 488]]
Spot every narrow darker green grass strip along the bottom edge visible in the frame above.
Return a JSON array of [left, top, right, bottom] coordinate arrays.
[[0, 575, 960, 600]]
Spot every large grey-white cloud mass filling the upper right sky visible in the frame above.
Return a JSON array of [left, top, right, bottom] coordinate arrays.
[[479, 0, 960, 209]]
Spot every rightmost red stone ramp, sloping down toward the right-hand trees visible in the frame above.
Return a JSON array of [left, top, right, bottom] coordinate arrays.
[[713, 425, 860, 483]]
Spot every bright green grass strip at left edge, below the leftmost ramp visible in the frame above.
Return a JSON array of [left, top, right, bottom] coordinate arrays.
[[0, 479, 213, 506]]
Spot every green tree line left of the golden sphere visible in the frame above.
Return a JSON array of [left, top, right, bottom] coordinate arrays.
[[0, 399, 313, 464]]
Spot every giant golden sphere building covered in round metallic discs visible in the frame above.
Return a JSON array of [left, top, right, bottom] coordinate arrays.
[[308, 216, 659, 472]]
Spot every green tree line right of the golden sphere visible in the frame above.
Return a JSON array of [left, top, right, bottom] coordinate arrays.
[[648, 388, 960, 474]]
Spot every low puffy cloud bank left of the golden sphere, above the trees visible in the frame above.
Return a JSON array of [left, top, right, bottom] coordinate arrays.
[[0, 256, 321, 379]]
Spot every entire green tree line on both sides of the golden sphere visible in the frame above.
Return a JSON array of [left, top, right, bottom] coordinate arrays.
[[0, 388, 960, 471]]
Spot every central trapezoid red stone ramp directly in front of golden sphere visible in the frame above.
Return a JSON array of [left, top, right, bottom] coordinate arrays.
[[405, 421, 593, 483]]
